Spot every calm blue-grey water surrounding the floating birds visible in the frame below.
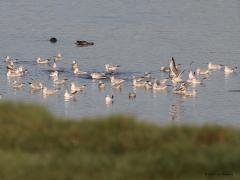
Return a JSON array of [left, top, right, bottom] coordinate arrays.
[[0, 0, 240, 125]]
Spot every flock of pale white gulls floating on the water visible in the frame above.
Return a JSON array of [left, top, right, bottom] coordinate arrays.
[[1, 53, 237, 104]]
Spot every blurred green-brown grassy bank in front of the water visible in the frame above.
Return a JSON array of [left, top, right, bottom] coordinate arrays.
[[0, 102, 240, 180]]
